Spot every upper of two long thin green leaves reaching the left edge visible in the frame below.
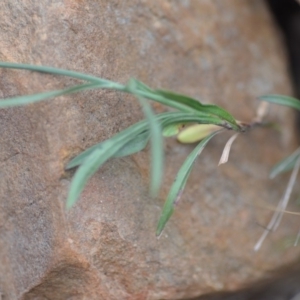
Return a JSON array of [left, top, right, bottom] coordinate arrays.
[[0, 62, 124, 89]]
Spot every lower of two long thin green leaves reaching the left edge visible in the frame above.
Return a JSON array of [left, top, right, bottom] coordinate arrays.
[[0, 83, 99, 108]]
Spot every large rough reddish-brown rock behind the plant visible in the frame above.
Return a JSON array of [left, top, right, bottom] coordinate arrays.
[[0, 0, 299, 300]]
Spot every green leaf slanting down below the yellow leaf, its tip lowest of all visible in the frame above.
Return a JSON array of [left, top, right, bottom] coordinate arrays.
[[156, 131, 220, 236]]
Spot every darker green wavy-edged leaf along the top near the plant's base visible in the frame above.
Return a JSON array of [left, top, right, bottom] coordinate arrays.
[[155, 90, 240, 130]]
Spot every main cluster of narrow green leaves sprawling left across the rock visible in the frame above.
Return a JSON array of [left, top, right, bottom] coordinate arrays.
[[0, 62, 248, 234]]
